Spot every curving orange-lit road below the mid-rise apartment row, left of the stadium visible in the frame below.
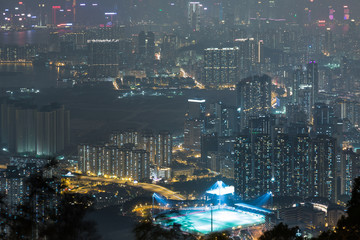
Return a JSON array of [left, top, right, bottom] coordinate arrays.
[[80, 176, 185, 200]]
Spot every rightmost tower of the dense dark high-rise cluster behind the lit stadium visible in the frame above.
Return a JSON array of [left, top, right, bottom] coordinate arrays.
[[310, 135, 336, 202]]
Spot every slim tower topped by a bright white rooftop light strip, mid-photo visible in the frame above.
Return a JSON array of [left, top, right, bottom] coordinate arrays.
[[184, 99, 206, 152]]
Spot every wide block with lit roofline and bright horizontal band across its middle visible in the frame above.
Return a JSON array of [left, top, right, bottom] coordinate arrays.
[[203, 47, 239, 87]]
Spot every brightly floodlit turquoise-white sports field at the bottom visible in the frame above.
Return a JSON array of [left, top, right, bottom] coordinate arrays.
[[156, 208, 265, 234]]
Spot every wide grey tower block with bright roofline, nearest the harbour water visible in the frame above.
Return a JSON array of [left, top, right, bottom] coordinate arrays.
[[87, 39, 122, 78]]
